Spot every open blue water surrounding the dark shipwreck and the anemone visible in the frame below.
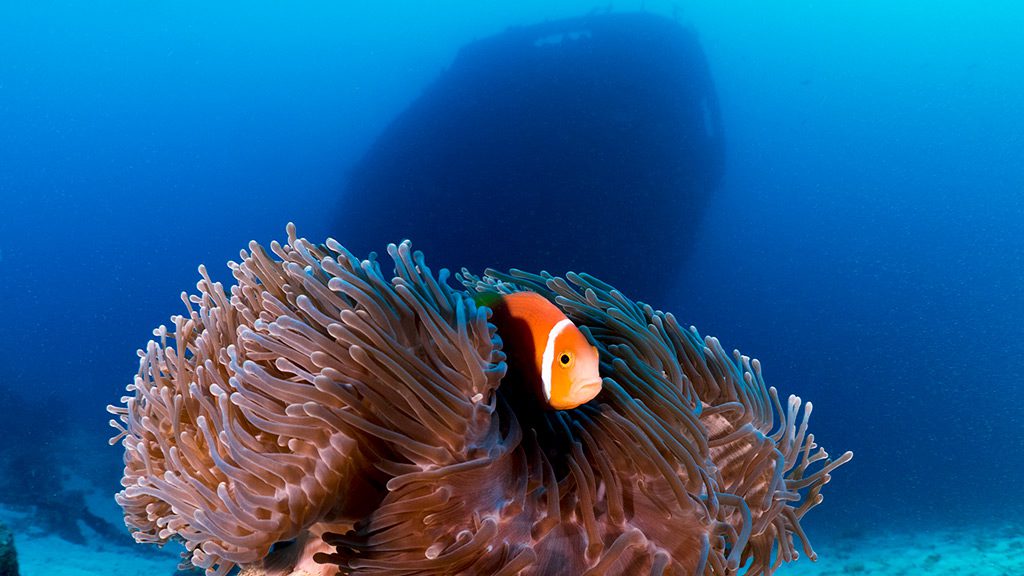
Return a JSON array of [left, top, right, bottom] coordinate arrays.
[[0, 1, 1024, 575]]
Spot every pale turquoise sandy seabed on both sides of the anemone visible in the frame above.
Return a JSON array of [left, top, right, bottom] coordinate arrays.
[[0, 500, 1024, 576]]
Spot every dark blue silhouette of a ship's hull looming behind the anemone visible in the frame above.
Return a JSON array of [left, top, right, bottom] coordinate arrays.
[[335, 13, 724, 303]]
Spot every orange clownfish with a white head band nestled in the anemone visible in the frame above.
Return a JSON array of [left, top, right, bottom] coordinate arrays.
[[473, 292, 601, 410]]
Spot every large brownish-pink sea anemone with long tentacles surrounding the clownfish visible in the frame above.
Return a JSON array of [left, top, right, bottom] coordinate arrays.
[[110, 224, 851, 576]]
